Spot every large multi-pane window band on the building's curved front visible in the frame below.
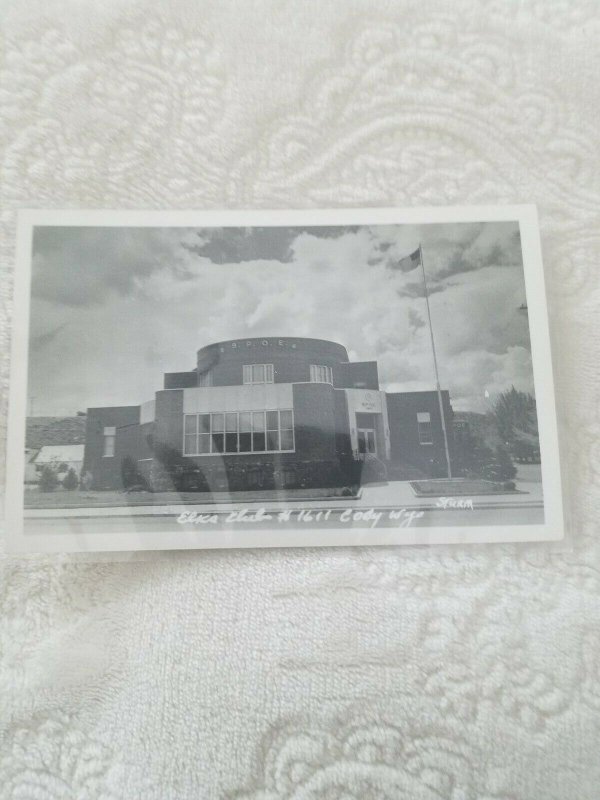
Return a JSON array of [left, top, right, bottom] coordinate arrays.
[[183, 409, 294, 456]]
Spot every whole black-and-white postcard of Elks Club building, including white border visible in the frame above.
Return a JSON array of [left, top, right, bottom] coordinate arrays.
[[8, 206, 563, 551]]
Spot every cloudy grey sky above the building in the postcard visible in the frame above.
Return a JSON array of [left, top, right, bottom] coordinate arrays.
[[28, 222, 533, 415]]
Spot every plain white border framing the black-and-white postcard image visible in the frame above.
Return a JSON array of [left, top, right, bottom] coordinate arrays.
[[5, 205, 564, 553]]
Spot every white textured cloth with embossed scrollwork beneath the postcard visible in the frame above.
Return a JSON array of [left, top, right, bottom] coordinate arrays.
[[0, 0, 600, 800]]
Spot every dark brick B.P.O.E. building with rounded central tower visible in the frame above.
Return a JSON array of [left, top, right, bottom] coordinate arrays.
[[83, 337, 452, 491]]
